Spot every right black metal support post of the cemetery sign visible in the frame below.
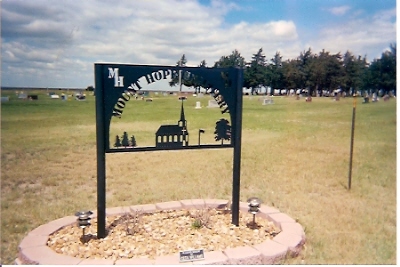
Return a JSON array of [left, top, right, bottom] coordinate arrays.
[[228, 69, 243, 226]]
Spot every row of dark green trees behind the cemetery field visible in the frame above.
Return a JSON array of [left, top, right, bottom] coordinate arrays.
[[170, 44, 396, 96]]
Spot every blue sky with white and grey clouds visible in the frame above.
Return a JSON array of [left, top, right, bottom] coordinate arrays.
[[0, 0, 396, 88]]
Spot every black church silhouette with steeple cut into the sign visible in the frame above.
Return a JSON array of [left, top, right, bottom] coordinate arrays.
[[156, 101, 189, 148]]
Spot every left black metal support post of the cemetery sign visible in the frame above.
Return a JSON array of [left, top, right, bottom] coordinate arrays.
[[94, 64, 106, 238]]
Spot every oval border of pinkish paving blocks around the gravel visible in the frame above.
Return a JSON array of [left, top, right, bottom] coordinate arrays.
[[15, 199, 305, 265]]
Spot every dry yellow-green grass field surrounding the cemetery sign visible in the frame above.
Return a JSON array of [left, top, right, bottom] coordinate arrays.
[[1, 91, 396, 264]]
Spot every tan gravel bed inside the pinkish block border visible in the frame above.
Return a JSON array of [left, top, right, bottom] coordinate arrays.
[[47, 209, 280, 260]]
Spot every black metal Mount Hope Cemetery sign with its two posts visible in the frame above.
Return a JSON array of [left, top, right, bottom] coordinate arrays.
[[95, 63, 243, 238]]
